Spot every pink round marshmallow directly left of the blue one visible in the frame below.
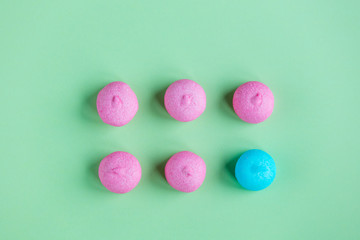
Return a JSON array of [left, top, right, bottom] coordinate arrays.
[[165, 151, 206, 192]]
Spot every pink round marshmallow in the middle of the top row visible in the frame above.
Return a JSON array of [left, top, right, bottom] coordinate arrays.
[[164, 79, 206, 122]]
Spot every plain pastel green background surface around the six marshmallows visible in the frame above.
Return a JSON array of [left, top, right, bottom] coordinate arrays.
[[0, 0, 360, 240]]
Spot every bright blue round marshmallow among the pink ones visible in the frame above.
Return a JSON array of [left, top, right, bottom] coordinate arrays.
[[235, 149, 276, 191]]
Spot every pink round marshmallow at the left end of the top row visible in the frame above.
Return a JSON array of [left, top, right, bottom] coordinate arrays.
[[96, 82, 139, 127]]
